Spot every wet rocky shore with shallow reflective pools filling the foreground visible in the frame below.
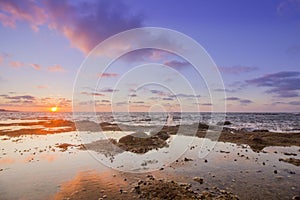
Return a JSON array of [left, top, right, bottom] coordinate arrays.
[[0, 120, 300, 199]]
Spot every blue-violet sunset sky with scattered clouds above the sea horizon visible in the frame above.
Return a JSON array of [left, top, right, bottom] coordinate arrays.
[[0, 0, 300, 112]]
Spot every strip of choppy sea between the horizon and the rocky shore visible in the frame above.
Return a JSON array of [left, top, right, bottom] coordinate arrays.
[[0, 112, 300, 132]]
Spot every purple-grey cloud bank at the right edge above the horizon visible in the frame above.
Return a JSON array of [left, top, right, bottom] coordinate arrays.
[[246, 71, 300, 98]]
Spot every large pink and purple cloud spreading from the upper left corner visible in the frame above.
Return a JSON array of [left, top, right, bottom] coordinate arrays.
[[0, 0, 142, 54]]
